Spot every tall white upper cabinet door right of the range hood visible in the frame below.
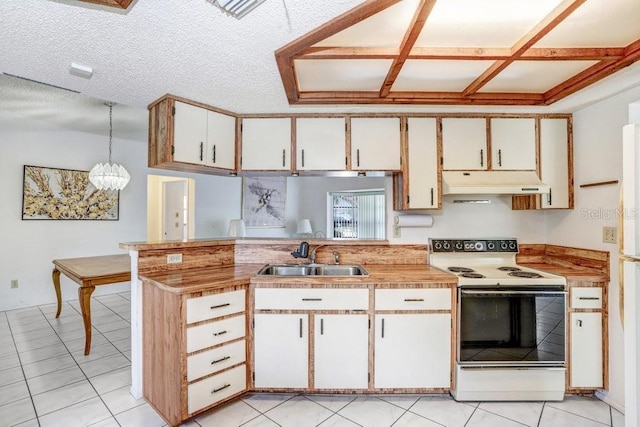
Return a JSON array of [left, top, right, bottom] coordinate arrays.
[[540, 118, 573, 209]]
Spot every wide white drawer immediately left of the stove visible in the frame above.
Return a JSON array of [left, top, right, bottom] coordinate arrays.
[[375, 288, 451, 310]]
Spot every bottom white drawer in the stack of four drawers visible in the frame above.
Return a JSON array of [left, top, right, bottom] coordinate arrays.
[[187, 365, 247, 414]]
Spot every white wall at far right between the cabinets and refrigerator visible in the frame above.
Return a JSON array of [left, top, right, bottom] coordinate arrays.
[[547, 83, 640, 409]]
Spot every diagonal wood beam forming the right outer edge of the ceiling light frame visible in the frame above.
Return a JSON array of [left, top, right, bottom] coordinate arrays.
[[544, 39, 640, 105]]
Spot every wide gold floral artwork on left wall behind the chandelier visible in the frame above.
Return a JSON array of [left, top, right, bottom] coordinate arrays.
[[22, 165, 120, 221]]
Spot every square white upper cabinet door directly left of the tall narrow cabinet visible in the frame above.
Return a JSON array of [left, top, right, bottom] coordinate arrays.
[[351, 117, 400, 171]]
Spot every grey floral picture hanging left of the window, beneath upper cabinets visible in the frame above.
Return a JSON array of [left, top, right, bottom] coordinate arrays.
[[242, 177, 287, 228]]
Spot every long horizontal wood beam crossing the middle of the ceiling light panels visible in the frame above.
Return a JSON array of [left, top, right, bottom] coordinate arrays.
[[295, 47, 625, 61]]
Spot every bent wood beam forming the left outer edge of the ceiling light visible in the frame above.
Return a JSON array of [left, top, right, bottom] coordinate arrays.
[[275, 0, 401, 103]]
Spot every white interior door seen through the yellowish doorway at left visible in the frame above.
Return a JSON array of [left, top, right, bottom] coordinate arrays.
[[162, 181, 187, 240]]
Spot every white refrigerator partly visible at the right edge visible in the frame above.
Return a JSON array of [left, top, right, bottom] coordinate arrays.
[[618, 124, 640, 427]]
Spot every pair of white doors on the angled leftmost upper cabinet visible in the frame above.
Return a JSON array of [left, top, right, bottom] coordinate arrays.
[[173, 101, 236, 169]]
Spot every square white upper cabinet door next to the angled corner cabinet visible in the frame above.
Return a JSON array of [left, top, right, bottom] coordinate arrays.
[[241, 118, 291, 170]]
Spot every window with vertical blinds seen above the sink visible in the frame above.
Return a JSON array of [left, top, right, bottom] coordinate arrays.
[[327, 190, 385, 239]]
